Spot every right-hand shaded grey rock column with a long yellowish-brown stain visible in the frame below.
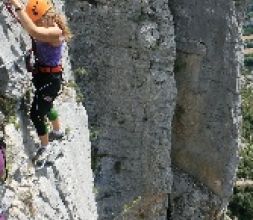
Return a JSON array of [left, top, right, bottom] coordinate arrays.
[[170, 0, 242, 219]]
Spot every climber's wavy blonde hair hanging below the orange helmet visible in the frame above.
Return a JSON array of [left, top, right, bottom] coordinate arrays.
[[43, 9, 73, 42]]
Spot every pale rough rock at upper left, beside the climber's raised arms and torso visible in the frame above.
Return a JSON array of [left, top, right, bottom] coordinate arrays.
[[0, 2, 29, 97]]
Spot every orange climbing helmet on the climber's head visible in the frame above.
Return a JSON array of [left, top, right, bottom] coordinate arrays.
[[26, 0, 52, 21]]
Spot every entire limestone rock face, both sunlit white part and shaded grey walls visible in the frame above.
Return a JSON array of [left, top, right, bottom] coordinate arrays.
[[0, 0, 242, 220]]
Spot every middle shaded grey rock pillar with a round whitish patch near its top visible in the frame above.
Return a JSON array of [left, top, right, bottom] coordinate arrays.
[[67, 0, 176, 220]]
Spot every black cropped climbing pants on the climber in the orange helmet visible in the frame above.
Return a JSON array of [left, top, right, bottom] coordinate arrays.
[[30, 73, 62, 136]]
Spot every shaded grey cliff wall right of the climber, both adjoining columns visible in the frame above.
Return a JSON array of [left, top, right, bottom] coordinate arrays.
[[67, 0, 242, 219]]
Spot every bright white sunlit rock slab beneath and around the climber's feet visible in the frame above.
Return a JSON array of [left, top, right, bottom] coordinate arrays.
[[0, 97, 97, 220]]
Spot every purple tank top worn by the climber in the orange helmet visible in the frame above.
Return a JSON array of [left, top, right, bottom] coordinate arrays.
[[35, 41, 63, 66]]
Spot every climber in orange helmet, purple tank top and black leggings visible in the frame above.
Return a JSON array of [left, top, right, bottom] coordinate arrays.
[[9, 0, 71, 165]]
